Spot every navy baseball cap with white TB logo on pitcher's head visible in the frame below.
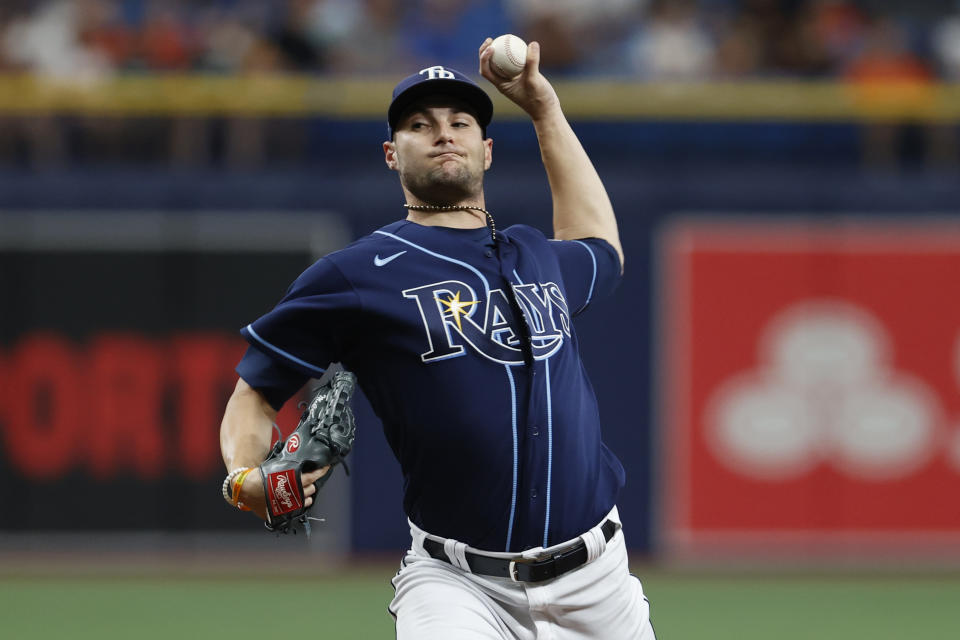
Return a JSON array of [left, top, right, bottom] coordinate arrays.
[[387, 65, 493, 140]]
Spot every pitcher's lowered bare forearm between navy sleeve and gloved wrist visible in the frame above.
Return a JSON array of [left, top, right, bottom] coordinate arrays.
[[220, 379, 277, 471]]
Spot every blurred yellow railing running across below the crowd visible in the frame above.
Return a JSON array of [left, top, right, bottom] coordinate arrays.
[[0, 74, 960, 122]]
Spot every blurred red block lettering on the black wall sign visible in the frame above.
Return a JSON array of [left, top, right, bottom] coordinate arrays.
[[0, 332, 298, 482]]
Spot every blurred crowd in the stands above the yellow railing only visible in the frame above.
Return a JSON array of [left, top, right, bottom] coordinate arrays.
[[0, 0, 960, 80]]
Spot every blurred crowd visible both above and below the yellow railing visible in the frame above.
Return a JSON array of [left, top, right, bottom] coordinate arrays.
[[0, 0, 960, 169]]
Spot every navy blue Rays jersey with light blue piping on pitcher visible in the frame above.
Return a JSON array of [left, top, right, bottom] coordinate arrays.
[[237, 220, 624, 551]]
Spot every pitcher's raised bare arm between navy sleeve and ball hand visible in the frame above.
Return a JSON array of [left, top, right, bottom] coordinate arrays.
[[533, 104, 623, 265]]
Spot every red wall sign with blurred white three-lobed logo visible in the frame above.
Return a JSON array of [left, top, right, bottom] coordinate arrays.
[[659, 220, 960, 552]]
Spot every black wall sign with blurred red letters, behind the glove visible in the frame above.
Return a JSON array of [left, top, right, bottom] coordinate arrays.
[[0, 218, 330, 539]]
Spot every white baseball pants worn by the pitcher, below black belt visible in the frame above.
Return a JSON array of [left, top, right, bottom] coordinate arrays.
[[389, 507, 656, 640]]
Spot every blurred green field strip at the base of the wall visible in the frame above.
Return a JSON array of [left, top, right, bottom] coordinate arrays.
[[0, 564, 960, 640]]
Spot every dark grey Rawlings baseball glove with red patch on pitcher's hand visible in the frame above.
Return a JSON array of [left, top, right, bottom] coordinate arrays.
[[260, 371, 357, 535]]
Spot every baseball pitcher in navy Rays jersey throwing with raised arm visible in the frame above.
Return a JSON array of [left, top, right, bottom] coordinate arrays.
[[221, 39, 654, 640]]
